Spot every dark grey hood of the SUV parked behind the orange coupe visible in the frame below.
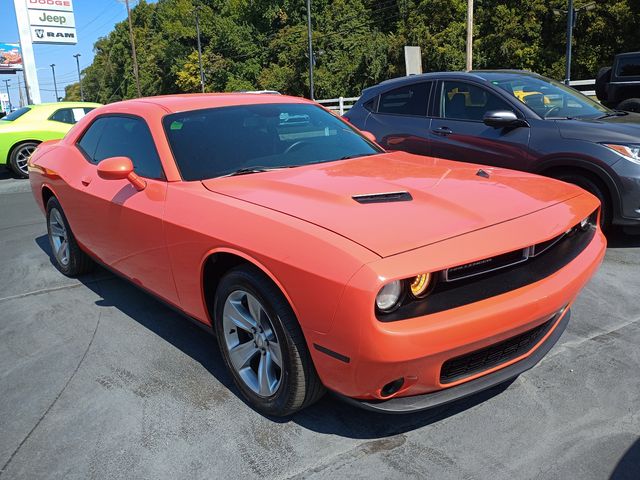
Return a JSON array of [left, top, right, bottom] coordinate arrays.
[[556, 113, 640, 143]]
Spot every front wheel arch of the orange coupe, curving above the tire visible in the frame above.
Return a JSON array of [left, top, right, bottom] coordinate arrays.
[[200, 248, 300, 326]]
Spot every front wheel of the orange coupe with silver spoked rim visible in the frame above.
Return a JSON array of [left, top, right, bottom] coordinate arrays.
[[214, 265, 324, 416]]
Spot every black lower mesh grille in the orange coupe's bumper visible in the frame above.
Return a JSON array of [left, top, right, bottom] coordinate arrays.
[[440, 316, 557, 383]]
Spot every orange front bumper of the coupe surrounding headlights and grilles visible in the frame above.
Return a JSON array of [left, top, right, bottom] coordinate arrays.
[[306, 194, 606, 408]]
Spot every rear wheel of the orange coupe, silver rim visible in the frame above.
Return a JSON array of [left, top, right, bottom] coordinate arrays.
[[47, 197, 93, 277]]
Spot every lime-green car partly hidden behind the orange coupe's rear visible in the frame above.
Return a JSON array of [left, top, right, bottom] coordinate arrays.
[[0, 102, 100, 178]]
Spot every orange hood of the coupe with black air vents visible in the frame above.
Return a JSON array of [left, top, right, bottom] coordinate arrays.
[[203, 152, 582, 257]]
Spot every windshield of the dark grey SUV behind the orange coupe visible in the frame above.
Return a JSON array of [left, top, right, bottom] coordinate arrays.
[[482, 74, 613, 119]]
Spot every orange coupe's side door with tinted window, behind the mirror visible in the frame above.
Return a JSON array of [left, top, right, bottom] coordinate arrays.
[[77, 114, 178, 304]]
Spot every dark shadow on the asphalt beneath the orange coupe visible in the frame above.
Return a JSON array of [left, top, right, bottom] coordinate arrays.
[[36, 235, 512, 439]]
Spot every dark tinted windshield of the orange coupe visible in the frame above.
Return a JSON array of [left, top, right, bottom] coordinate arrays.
[[163, 103, 382, 180]]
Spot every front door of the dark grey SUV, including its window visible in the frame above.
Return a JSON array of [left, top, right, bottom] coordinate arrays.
[[429, 80, 530, 169]]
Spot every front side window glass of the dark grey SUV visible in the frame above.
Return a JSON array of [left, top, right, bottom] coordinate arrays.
[[440, 81, 513, 122]]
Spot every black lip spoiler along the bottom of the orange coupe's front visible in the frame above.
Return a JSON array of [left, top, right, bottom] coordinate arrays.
[[334, 309, 571, 413]]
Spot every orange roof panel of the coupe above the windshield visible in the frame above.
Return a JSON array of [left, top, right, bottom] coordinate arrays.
[[112, 93, 313, 113]]
